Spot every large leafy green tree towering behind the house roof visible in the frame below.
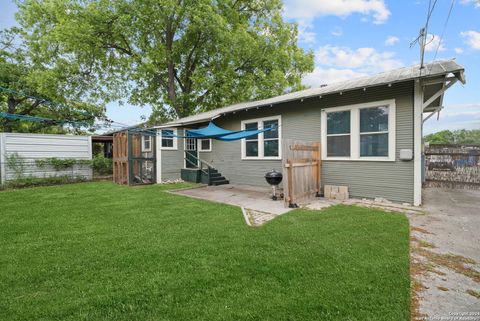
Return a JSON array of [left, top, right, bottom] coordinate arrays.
[[17, 0, 313, 121]]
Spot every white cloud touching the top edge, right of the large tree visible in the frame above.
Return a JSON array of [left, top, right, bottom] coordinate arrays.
[[285, 0, 390, 24]]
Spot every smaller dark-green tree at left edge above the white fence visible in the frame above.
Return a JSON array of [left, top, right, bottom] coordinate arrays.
[[0, 28, 105, 133]]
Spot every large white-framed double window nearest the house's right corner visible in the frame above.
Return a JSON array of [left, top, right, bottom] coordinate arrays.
[[322, 100, 395, 161]]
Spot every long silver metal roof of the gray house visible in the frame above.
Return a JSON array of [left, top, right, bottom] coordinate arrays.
[[155, 59, 465, 128]]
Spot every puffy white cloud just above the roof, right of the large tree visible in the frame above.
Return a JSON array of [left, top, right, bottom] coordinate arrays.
[[303, 45, 403, 87]]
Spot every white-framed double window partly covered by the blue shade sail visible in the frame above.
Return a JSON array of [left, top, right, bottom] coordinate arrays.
[[241, 116, 281, 159]]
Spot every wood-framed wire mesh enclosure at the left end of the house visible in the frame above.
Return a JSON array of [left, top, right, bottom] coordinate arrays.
[[113, 130, 157, 185]]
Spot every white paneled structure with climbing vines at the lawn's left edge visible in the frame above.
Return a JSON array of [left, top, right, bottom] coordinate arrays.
[[0, 133, 92, 184]]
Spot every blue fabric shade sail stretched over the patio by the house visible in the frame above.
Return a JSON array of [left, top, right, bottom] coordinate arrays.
[[162, 122, 277, 141]]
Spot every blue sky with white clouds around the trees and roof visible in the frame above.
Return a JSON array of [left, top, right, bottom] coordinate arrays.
[[0, 0, 480, 133]]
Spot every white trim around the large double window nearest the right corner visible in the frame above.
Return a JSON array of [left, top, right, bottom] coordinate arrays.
[[321, 99, 396, 162]]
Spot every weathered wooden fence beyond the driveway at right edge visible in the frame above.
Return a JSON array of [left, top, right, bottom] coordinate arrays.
[[425, 145, 480, 189]]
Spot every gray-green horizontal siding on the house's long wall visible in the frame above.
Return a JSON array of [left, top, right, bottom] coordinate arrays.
[[158, 82, 413, 203]]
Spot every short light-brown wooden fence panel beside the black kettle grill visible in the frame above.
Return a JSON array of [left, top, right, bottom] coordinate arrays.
[[282, 139, 322, 207]]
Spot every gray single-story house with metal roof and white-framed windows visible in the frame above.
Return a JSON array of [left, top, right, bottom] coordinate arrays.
[[151, 60, 465, 205]]
